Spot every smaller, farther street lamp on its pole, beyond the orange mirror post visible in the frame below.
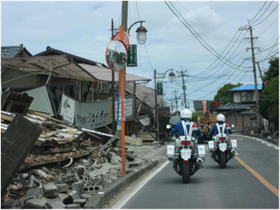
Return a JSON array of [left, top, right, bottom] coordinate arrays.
[[154, 69, 175, 140]]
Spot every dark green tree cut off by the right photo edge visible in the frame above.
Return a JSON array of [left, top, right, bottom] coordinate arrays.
[[259, 58, 279, 130]]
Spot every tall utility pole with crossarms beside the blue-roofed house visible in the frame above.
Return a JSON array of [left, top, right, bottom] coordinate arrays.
[[239, 22, 260, 129]]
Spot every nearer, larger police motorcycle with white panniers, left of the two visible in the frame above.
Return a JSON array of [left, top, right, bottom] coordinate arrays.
[[166, 121, 206, 183]]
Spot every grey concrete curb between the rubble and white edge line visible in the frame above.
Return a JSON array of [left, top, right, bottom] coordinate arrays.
[[84, 160, 159, 209]]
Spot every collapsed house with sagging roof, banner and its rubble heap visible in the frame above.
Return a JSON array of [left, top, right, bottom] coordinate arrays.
[[0, 45, 167, 209]]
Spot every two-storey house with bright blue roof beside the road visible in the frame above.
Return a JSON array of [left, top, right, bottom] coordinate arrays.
[[217, 84, 262, 130]]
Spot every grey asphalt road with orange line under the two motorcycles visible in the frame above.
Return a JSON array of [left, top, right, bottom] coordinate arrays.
[[122, 135, 279, 209]]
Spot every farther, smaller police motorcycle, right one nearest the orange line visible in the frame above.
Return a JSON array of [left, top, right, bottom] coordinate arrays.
[[208, 123, 237, 168]]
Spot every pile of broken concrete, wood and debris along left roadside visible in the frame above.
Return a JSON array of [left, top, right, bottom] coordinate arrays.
[[0, 111, 158, 209]]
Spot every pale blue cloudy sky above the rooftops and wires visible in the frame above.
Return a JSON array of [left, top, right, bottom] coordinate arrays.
[[0, 0, 279, 109]]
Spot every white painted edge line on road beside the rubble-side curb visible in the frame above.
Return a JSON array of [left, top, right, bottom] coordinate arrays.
[[111, 161, 170, 209]]
